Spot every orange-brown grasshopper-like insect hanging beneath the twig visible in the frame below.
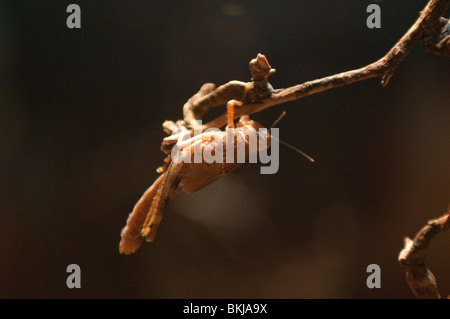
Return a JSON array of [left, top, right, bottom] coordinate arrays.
[[119, 86, 275, 255]]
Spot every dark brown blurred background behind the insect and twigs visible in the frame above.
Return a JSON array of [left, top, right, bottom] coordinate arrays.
[[0, 0, 450, 299]]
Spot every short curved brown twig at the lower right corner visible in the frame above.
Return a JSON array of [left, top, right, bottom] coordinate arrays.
[[398, 206, 450, 299]]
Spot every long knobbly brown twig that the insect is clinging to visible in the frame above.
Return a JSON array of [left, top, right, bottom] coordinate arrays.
[[171, 0, 450, 134]]
